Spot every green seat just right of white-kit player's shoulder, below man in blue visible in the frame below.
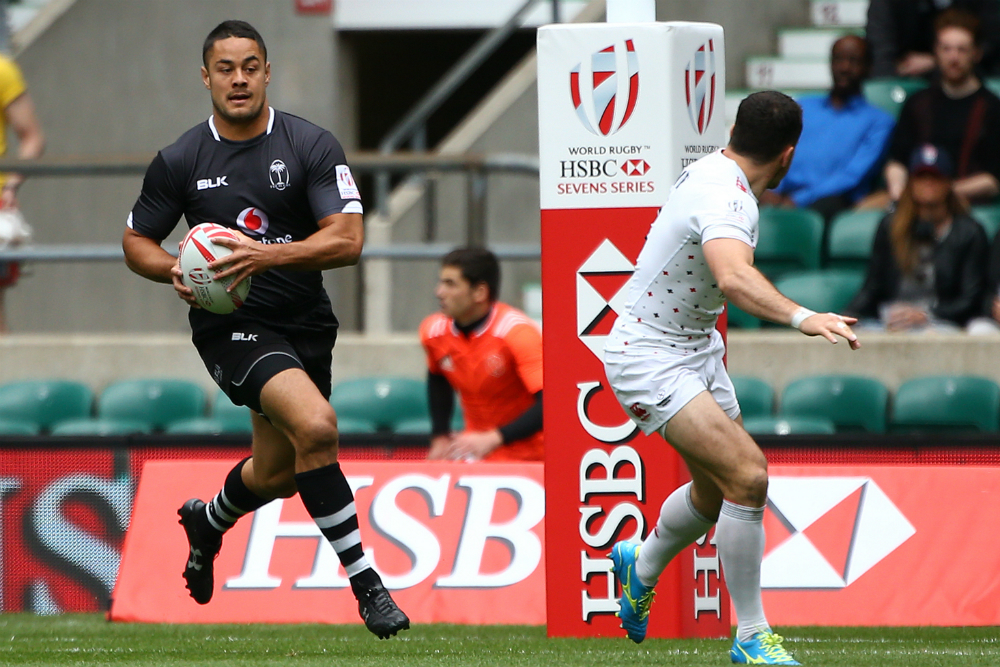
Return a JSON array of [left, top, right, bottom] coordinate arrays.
[[754, 207, 823, 280]]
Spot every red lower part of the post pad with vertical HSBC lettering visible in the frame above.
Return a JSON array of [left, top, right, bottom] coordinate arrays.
[[542, 208, 730, 637]]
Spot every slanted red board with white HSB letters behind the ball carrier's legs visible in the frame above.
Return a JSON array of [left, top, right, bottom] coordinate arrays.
[[111, 461, 545, 625]]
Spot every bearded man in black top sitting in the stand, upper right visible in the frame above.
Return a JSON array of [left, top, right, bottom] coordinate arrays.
[[885, 9, 1000, 204]]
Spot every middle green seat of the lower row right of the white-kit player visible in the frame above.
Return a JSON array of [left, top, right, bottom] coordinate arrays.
[[779, 375, 889, 433]]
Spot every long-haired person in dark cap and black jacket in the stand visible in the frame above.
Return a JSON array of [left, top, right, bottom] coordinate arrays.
[[845, 144, 989, 331]]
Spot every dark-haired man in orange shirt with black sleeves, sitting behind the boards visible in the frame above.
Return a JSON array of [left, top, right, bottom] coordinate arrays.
[[420, 248, 543, 461]]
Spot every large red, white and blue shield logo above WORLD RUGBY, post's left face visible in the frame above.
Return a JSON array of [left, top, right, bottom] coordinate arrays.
[[569, 39, 639, 137]]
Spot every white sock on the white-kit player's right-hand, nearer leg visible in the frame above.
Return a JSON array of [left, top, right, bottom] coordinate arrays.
[[715, 500, 771, 642]]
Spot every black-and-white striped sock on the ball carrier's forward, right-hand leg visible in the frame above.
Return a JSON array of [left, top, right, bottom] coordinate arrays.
[[295, 463, 374, 584]]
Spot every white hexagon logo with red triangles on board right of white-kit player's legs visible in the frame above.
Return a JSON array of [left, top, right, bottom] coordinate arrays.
[[761, 477, 917, 589]]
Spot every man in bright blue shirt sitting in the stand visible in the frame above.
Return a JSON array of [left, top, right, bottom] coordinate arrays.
[[761, 35, 893, 223]]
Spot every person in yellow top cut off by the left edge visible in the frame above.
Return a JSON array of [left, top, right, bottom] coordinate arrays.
[[0, 55, 45, 334]]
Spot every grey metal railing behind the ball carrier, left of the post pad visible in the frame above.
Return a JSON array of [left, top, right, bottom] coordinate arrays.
[[0, 152, 541, 262]]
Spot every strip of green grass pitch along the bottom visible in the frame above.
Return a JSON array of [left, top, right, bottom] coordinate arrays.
[[0, 614, 1000, 667]]
